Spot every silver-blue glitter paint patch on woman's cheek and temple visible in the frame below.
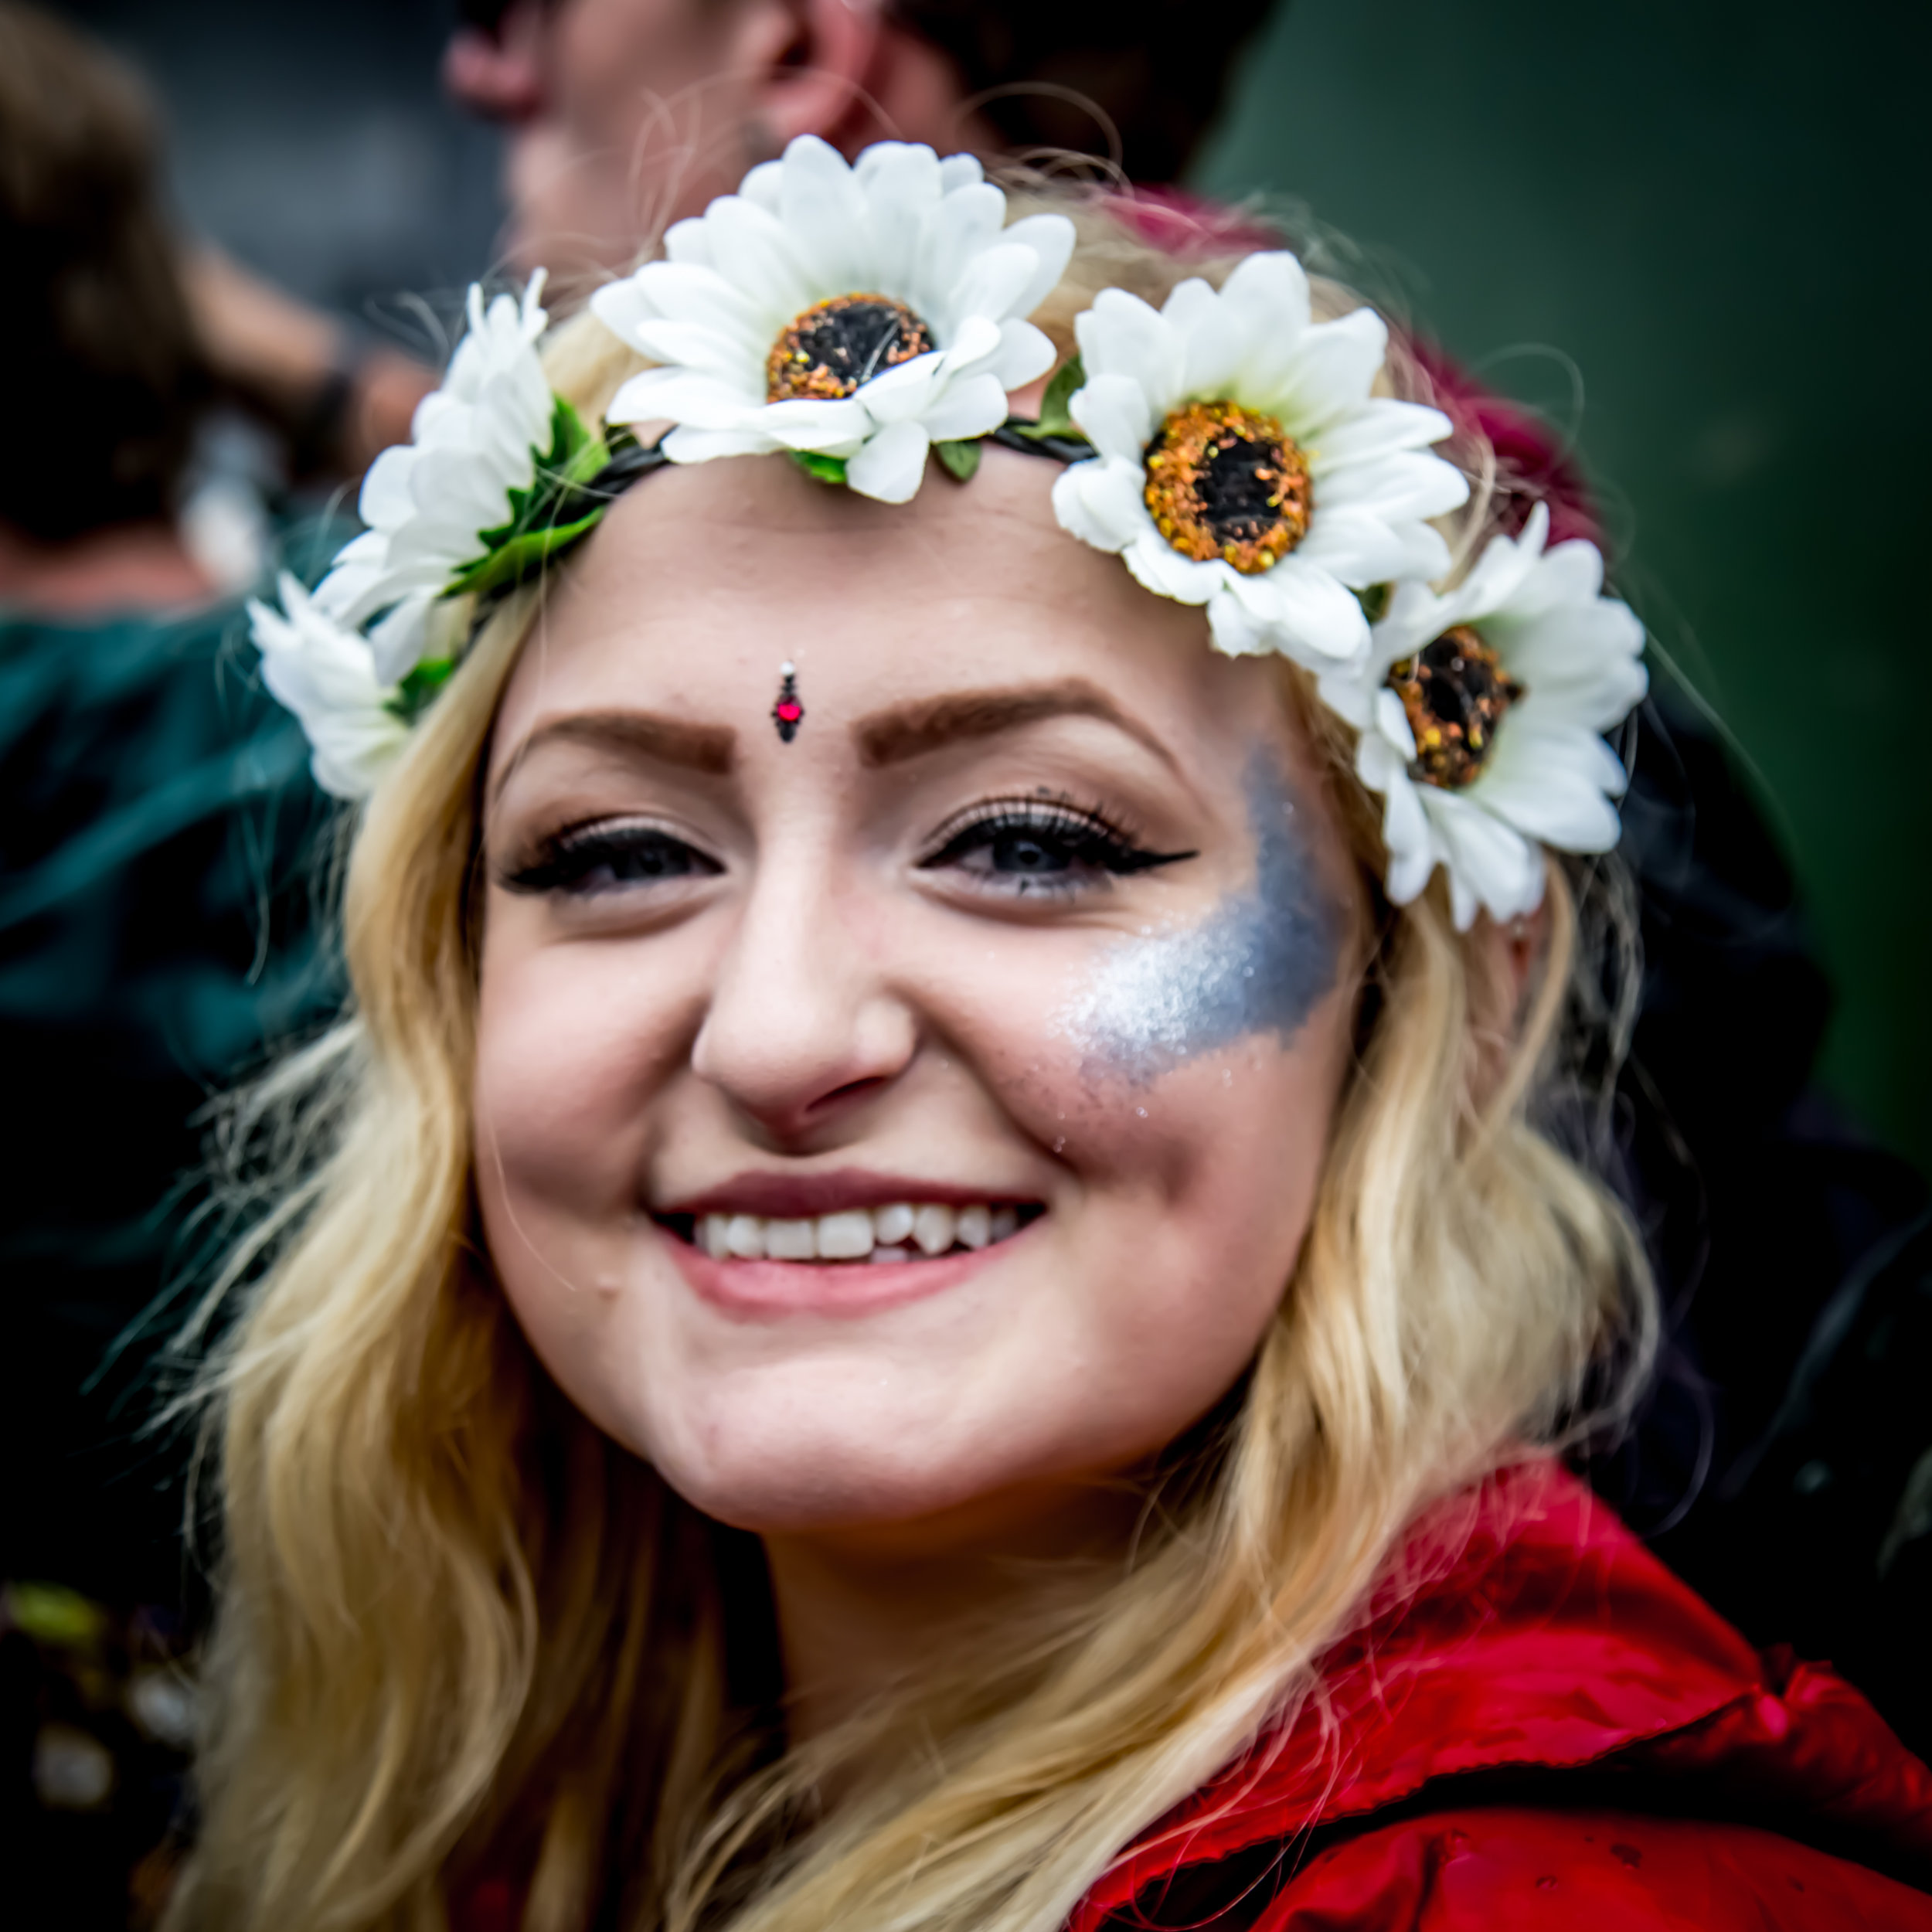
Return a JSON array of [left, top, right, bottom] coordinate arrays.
[[1053, 752, 1341, 1084]]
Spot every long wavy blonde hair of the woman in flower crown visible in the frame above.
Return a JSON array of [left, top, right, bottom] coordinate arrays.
[[174, 197, 1654, 1932]]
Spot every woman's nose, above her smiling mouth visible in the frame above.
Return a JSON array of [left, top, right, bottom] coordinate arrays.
[[692, 868, 918, 1144]]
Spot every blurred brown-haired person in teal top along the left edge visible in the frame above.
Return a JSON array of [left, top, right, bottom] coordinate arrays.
[[0, 4, 327, 1928]]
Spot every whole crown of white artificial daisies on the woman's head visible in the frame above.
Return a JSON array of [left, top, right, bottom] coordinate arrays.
[[250, 135, 1646, 927]]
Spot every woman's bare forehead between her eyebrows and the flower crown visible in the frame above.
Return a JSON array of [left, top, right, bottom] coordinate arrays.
[[498, 448, 1279, 757]]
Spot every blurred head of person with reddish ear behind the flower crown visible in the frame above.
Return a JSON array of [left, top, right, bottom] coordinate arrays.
[[444, 0, 1274, 286]]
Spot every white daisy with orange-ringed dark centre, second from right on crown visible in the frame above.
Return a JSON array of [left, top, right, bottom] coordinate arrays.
[[1053, 253, 1468, 671]]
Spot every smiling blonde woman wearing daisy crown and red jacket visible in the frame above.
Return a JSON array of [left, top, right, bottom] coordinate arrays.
[[176, 149, 1932, 1932]]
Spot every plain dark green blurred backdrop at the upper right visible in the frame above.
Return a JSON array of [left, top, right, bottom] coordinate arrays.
[[1196, 0, 1932, 1165]]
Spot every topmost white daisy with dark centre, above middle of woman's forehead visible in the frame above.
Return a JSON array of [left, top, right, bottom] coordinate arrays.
[[591, 135, 1074, 502]]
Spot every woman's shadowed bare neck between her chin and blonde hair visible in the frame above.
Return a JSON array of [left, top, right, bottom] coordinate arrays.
[[765, 1484, 1144, 1745]]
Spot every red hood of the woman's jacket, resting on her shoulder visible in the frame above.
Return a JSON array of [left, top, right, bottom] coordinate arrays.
[[1070, 1464, 1932, 1932]]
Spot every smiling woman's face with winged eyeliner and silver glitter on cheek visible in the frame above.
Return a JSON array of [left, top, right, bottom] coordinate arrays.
[[475, 448, 1362, 1540]]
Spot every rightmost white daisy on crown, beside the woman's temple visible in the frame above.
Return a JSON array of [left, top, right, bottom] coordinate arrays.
[[1321, 505, 1650, 931]]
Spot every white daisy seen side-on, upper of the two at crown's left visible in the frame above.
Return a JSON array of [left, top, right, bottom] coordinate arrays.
[[315, 269, 556, 684]]
